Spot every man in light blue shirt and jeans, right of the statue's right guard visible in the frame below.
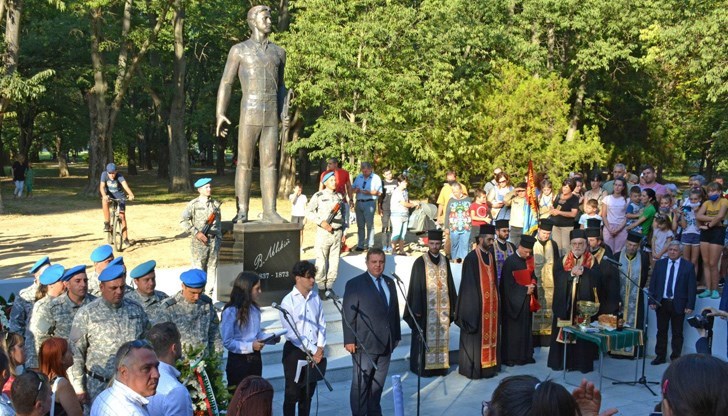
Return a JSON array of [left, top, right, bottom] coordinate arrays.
[[352, 162, 382, 251]]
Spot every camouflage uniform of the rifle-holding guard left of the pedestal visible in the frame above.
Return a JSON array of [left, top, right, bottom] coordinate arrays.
[[180, 197, 222, 285]]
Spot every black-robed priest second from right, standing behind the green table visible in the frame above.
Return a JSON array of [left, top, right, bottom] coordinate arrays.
[[584, 219, 619, 315]]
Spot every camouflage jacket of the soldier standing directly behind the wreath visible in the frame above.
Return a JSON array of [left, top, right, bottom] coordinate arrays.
[[157, 292, 222, 352]]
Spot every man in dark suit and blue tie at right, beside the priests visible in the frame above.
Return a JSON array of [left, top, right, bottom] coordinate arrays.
[[650, 241, 696, 365]]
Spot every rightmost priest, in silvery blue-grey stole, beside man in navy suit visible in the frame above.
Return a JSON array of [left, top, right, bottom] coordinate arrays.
[[610, 232, 650, 358]]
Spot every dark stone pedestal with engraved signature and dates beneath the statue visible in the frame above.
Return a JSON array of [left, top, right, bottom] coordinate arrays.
[[217, 221, 303, 306]]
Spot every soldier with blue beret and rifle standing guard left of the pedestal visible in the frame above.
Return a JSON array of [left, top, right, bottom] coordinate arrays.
[[180, 178, 222, 296]]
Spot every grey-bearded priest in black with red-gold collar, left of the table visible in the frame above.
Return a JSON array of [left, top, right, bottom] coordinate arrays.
[[548, 230, 599, 373]]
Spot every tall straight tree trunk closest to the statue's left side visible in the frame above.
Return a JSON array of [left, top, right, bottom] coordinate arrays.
[[168, 0, 192, 192]]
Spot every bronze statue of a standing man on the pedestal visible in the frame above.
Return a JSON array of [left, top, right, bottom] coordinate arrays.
[[215, 6, 288, 223]]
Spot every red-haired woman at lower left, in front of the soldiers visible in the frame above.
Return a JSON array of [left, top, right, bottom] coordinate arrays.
[[38, 337, 83, 416]]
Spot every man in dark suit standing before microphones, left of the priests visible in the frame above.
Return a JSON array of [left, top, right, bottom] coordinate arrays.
[[343, 248, 402, 416]]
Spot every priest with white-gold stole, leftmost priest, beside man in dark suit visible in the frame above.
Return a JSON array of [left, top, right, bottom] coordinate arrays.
[[403, 230, 457, 377]]
